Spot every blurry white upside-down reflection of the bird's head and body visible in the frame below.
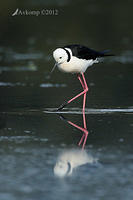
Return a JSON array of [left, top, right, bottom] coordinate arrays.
[[54, 149, 97, 177]]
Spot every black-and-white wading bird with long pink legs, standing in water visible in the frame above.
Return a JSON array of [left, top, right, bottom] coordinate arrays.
[[51, 44, 113, 112]]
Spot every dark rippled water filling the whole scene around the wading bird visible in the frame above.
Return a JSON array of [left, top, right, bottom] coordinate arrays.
[[0, 0, 133, 200]]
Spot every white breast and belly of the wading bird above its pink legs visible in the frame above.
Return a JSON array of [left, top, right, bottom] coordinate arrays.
[[58, 56, 98, 73]]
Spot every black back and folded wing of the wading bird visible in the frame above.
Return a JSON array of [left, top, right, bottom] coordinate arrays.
[[64, 44, 110, 60]]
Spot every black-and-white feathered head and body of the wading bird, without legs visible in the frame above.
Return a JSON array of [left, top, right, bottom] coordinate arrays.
[[53, 44, 111, 73]]
